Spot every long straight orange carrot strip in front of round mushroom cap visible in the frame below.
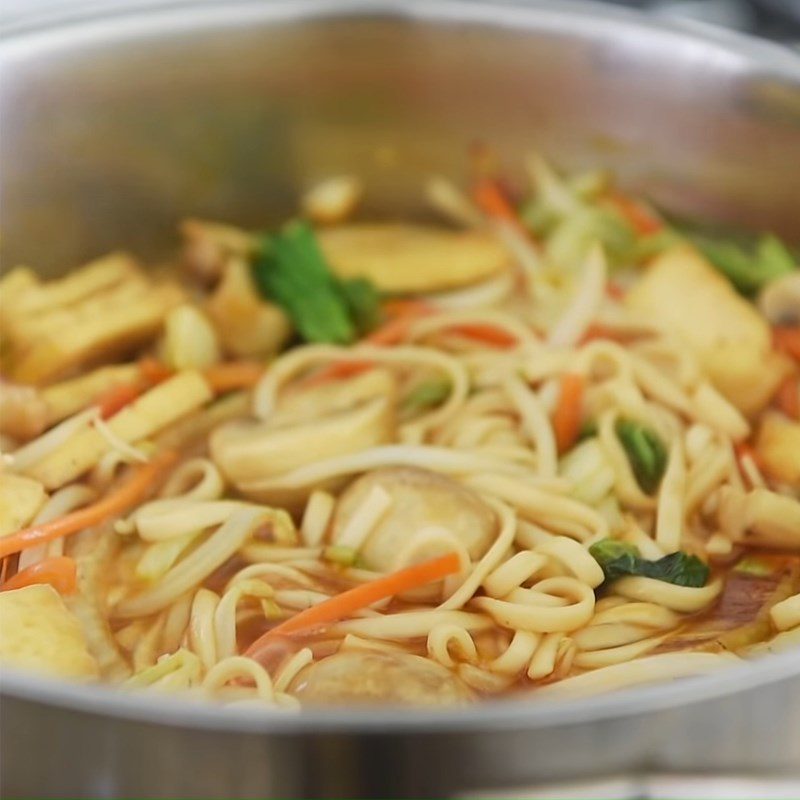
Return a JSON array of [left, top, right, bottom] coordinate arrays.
[[245, 553, 460, 659]]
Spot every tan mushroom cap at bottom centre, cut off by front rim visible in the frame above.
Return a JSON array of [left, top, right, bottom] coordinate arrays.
[[290, 650, 474, 706]]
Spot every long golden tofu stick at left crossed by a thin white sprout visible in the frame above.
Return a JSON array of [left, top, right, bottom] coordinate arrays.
[[27, 371, 213, 489]]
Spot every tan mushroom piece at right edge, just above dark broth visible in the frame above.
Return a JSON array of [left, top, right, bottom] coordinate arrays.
[[719, 487, 800, 550]]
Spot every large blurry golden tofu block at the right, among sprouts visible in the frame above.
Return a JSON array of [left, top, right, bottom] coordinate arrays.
[[625, 246, 790, 415]]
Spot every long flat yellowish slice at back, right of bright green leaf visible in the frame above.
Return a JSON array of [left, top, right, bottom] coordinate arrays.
[[317, 223, 509, 292]]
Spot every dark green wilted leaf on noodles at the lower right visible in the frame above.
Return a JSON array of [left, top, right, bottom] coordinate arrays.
[[589, 539, 710, 587]]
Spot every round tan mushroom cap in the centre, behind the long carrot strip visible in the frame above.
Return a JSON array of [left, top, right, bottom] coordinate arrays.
[[331, 467, 497, 572]]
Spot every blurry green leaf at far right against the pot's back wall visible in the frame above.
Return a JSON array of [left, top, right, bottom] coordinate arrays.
[[694, 234, 797, 295]]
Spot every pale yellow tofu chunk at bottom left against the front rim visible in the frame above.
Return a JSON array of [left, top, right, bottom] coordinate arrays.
[[0, 584, 99, 680]]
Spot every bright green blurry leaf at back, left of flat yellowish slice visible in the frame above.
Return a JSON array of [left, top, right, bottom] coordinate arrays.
[[253, 221, 378, 344]]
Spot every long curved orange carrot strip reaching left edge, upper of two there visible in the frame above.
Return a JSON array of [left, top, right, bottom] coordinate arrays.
[[0, 451, 178, 558]]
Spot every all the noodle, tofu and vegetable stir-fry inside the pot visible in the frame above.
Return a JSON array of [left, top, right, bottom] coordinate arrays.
[[0, 157, 800, 709]]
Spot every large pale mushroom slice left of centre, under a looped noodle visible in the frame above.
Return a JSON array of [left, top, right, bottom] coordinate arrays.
[[209, 370, 396, 508]]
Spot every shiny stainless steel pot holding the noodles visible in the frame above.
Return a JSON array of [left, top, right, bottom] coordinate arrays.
[[0, 0, 800, 797]]
